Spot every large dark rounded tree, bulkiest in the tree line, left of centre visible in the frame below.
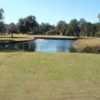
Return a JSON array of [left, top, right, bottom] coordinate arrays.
[[17, 16, 39, 34]]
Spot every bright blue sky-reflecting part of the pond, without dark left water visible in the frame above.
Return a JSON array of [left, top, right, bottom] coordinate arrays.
[[35, 39, 75, 52]]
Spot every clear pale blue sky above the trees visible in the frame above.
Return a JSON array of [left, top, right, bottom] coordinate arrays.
[[0, 0, 100, 24]]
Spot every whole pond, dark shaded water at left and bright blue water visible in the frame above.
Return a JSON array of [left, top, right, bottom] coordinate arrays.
[[0, 39, 75, 52]]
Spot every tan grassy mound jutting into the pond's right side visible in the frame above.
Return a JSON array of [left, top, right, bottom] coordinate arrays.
[[72, 38, 100, 53]]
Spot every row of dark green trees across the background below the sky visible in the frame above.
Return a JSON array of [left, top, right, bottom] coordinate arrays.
[[0, 8, 100, 36]]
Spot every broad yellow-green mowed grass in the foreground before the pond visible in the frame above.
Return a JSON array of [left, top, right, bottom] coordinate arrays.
[[0, 52, 100, 100]]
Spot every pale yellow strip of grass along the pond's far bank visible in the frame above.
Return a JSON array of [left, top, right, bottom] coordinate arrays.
[[0, 33, 77, 41]]
